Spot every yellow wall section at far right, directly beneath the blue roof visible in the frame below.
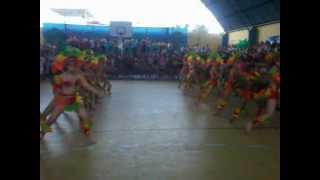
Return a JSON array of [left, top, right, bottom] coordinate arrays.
[[257, 23, 280, 42]]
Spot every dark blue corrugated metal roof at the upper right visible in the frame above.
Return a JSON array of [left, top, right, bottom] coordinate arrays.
[[202, 0, 280, 32]]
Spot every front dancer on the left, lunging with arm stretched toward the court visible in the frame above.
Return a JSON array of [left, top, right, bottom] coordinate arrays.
[[40, 47, 103, 139]]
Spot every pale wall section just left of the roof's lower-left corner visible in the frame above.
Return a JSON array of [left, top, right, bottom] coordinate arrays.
[[188, 33, 222, 50]]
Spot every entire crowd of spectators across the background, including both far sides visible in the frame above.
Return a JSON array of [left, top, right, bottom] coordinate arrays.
[[40, 36, 280, 79]]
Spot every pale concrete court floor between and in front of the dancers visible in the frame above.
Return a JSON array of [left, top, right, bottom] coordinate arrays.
[[40, 81, 280, 180]]
